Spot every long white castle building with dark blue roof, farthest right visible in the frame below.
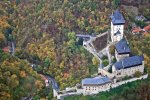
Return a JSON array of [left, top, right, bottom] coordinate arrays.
[[112, 56, 144, 79]]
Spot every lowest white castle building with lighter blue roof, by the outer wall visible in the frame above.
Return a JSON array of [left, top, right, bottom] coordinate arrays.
[[82, 76, 111, 95]]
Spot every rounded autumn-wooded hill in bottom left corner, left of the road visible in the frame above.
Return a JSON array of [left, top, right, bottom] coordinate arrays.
[[0, 51, 48, 100]]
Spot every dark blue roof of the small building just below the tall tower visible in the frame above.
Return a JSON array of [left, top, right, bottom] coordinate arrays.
[[115, 38, 130, 54]]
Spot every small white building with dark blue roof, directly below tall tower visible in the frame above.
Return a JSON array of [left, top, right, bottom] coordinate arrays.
[[115, 38, 131, 61]]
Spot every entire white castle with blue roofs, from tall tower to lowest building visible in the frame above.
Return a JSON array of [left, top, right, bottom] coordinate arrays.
[[82, 10, 144, 94]]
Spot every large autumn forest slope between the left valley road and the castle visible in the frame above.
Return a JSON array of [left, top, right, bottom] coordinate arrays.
[[11, 0, 111, 88]]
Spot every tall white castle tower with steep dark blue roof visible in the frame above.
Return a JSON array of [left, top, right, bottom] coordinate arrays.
[[111, 10, 125, 42]]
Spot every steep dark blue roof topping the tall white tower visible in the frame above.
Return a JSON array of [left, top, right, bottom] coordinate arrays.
[[111, 10, 125, 25]]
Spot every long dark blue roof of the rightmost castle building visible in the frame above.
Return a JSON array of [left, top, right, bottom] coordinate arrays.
[[114, 56, 144, 70]]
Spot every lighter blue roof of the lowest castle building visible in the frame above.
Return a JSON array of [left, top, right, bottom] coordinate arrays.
[[82, 76, 111, 85]]
